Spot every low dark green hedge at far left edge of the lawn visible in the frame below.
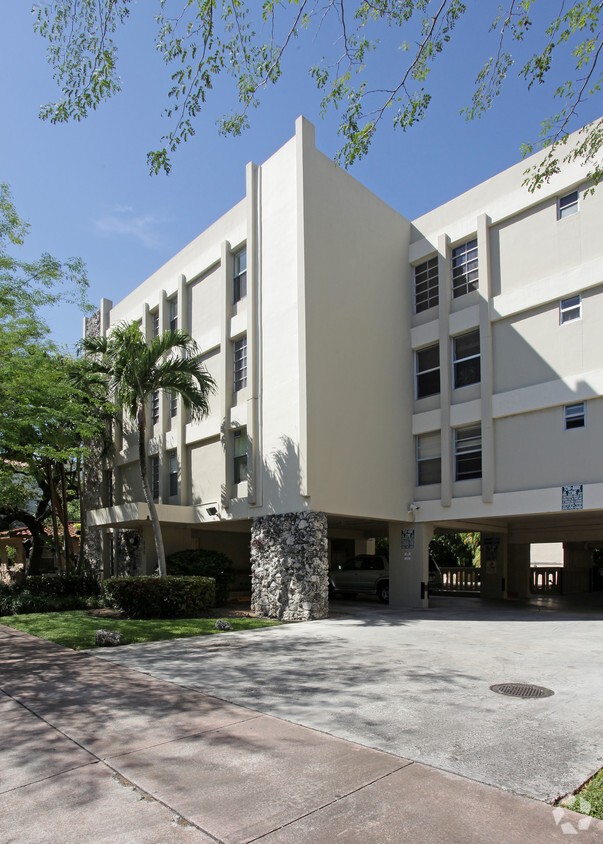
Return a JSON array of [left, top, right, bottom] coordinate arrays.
[[0, 574, 100, 615]]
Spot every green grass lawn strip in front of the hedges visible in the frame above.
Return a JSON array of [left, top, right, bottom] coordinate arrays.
[[0, 610, 279, 650]]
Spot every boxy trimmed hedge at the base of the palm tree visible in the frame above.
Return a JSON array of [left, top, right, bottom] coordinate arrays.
[[105, 576, 216, 618]]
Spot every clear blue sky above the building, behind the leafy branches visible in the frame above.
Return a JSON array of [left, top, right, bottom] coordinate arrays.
[[0, 0, 600, 346]]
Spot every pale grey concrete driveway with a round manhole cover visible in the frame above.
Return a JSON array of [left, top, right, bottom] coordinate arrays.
[[92, 598, 603, 800]]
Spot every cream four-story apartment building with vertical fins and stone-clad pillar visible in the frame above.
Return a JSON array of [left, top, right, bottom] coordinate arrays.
[[87, 118, 603, 617]]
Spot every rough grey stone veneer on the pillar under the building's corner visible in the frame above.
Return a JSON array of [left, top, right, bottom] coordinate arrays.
[[251, 512, 329, 621]]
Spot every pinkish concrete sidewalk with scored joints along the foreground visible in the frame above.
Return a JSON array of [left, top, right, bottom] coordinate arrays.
[[0, 627, 603, 844]]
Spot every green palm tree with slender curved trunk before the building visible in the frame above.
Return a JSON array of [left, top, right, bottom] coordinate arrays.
[[81, 322, 216, 577]]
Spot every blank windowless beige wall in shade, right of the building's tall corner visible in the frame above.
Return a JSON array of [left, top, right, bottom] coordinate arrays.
[[303, 130, 414, 519]]
